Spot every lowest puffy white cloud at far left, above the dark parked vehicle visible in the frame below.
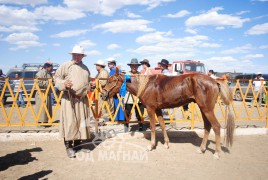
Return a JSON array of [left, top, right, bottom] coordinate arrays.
[[4, 33, 44, 50]]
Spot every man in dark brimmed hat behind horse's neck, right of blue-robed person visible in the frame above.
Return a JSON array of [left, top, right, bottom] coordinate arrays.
[[124, 58, 144, 132]]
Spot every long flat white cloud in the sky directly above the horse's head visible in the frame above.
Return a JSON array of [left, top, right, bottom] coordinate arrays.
[[93, 19, 154, 33]]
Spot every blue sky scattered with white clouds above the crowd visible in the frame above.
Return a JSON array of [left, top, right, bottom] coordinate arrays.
[[0, 0, 268, 76]]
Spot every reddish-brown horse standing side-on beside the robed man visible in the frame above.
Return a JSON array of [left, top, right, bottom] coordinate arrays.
[[102, 70, 234, 159]]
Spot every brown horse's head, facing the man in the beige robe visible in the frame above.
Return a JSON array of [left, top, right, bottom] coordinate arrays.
[[101, 68, 124, 101]]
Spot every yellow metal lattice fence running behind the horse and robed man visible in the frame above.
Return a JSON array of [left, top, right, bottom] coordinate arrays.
[[0, 78, 268, 129]]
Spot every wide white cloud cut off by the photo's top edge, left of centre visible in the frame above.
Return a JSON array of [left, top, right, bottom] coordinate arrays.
[[64, 0, 175, 16]]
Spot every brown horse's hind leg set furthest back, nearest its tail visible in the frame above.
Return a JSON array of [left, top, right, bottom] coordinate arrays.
[[204, 110, 221, 159]]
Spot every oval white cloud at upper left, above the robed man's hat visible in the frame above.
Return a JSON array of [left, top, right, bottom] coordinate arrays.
[[35, 6, 86, 21]]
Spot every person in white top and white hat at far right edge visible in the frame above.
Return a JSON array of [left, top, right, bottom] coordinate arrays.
[[251, 72, 265, 106]]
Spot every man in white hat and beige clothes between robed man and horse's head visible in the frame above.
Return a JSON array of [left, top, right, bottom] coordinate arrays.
[[91, 60, 109, 121]]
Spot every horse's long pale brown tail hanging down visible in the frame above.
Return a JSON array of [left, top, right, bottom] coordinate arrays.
[[217, 80, 235, 147]]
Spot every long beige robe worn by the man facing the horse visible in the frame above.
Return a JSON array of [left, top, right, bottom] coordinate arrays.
[[55, 61, 90, 141]]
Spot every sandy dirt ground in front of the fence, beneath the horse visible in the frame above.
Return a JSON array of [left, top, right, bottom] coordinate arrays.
[[0, 135, 268, 180]]
